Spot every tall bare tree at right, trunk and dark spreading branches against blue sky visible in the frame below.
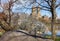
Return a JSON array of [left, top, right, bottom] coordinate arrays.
[[38, 0, 60, 40]]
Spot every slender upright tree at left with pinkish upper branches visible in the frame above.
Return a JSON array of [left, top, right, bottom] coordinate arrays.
[[1, 0, 18, 25]]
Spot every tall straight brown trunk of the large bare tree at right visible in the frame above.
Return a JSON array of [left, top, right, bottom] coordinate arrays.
[[51, 0, 56, 41]]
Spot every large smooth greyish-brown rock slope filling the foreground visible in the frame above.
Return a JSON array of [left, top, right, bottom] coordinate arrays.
[[0, 31, 53, 41]]
